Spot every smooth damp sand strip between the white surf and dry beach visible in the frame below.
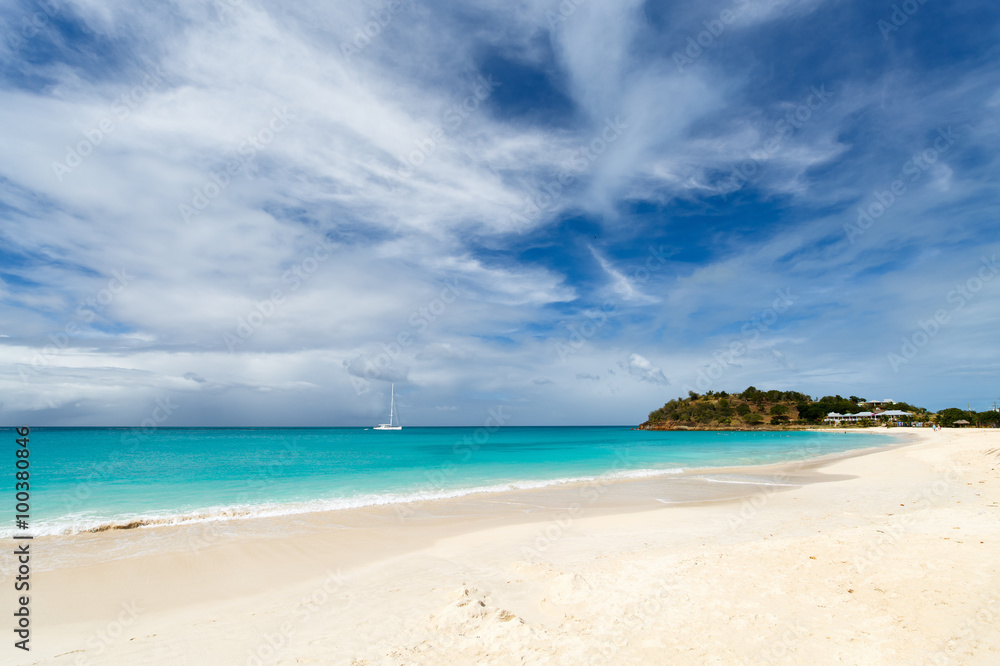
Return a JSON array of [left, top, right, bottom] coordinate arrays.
[[27, 428, 911, 570]]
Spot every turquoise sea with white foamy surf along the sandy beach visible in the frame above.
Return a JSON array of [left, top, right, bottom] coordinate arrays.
[[7, 426, 890, 536]]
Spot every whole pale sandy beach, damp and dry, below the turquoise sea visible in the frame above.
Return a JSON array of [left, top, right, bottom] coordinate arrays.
[[15, 430, 1000, 665]]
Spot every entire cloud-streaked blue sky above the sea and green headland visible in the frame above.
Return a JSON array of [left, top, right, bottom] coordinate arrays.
[[0, 0, 1000, 427]]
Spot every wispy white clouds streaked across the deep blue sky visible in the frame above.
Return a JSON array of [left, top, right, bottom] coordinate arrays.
[[0, 0, 998, 422]]
